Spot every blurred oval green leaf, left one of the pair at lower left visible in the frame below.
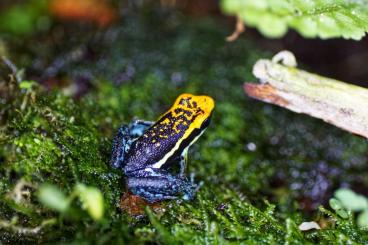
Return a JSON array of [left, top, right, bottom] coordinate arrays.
[[38, 184, 70, 213]]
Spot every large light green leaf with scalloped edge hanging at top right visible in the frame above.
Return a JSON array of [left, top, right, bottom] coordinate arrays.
[[221, 0, 368, 40]]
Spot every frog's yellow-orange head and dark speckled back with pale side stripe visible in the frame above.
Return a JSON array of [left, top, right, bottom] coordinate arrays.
[[124, 94, 214, 174]]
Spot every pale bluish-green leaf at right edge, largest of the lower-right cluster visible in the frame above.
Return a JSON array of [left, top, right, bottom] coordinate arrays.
[[335, 188, 368, 211]]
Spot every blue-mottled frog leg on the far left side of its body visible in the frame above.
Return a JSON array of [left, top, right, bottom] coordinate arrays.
[[110, 125, 132, 168]]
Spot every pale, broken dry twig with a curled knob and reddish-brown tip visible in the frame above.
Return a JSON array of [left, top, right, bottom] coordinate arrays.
[[244, 51, 368, 138]]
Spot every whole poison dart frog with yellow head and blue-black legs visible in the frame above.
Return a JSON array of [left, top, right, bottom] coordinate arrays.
[[110, 94, 215, 203]]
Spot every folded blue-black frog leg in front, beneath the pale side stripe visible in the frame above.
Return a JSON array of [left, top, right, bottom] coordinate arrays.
[[127, 168, 197, 202]]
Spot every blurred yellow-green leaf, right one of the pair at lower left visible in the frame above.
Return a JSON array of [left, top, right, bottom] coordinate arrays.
[[76, 184, 104, 220]]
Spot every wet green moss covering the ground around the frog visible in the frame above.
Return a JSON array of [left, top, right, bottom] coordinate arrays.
[[0, 10, 368, 244]]
